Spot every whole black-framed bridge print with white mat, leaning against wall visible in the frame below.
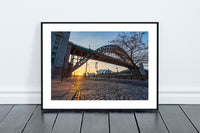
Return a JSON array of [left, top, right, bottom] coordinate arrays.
[[41, 22, 158, 110]]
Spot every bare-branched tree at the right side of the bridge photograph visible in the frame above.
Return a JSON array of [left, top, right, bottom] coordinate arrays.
[[109, 32, 148, 79]]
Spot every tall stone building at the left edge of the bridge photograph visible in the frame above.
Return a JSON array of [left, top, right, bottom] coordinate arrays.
[[51, 32, 71, 80]]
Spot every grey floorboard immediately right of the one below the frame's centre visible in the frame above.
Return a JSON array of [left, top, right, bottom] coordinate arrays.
[[109, 112, 139, 133]]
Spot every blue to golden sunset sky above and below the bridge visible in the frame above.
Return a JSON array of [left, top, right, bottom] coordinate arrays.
[[69, 32, 148, 75]]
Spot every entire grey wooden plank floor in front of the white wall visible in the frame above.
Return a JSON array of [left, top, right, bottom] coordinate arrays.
[[0, 105, 200, 133]]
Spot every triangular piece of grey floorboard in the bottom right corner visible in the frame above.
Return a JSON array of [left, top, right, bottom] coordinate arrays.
[[180, 105, 200, 132]]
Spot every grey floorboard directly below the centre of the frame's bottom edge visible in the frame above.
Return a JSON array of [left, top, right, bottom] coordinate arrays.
[[81, 112, 109, 133]]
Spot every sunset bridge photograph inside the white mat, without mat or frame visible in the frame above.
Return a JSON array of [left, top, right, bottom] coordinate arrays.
[[51, 31, 148, 100]]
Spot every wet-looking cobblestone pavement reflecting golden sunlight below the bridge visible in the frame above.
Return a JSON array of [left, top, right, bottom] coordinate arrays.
[[51, 77, 148, 100]]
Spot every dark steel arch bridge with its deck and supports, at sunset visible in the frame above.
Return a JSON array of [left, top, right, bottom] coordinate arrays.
[[63, 42, 143, 79]]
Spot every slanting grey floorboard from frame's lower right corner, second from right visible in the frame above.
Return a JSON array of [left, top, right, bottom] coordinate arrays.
[[159, 105, 197, 133]]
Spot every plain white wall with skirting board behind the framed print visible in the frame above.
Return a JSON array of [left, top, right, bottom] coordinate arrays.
[[0, 0, 200, 103]]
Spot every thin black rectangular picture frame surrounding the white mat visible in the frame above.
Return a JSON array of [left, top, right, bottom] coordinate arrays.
[[41, 22, 159, 111]]
